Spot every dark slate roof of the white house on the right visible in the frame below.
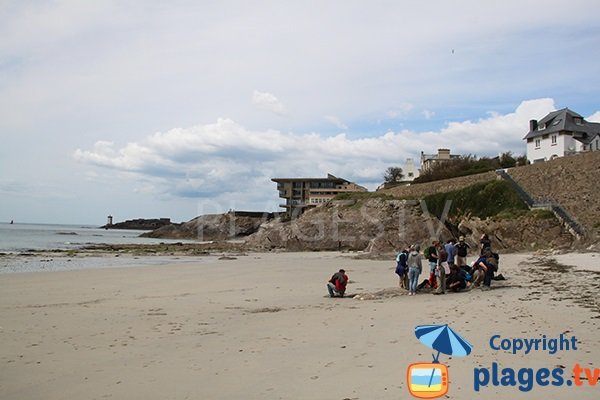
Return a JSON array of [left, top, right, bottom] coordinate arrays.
[[523, 108, 600, 144]]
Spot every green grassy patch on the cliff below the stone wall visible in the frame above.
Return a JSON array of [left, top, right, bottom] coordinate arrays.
[[423, 180, 529, 219]]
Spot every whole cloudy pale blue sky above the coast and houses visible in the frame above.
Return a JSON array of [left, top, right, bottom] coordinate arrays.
[[0, 0, 600, 225]]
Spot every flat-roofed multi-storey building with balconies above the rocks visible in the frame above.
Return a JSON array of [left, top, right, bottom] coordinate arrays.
[[271, 174, 367, 216]]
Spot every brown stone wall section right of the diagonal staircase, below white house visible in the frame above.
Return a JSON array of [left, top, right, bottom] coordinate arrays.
[[509, 151, 600, 240]]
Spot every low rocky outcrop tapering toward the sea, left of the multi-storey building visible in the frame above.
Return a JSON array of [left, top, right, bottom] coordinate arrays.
[[141, 211, 273, 241]]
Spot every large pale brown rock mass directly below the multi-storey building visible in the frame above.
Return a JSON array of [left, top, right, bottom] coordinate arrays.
[[246, 198, 449, 253]]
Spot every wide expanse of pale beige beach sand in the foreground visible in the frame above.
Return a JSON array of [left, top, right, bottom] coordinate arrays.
[[0, 253, 600, 400]]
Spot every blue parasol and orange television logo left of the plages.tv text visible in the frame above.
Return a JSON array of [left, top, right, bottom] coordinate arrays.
[[406, 324, 473, 399]]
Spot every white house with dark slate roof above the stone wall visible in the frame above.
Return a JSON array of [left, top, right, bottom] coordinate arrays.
[[523, 108, 600, 163]]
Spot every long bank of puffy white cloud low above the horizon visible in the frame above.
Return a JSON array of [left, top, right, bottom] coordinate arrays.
[[74, 99, 555, 209]]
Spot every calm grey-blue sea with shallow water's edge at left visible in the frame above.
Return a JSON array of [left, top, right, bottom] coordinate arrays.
[[0, 223, 207, 274]]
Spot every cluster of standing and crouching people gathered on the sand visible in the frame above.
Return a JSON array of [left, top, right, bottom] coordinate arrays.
[[396, 234, 499, 296]]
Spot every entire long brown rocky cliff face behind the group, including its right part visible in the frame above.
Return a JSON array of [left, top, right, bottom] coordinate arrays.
[[246, 198, 573, 256]]
